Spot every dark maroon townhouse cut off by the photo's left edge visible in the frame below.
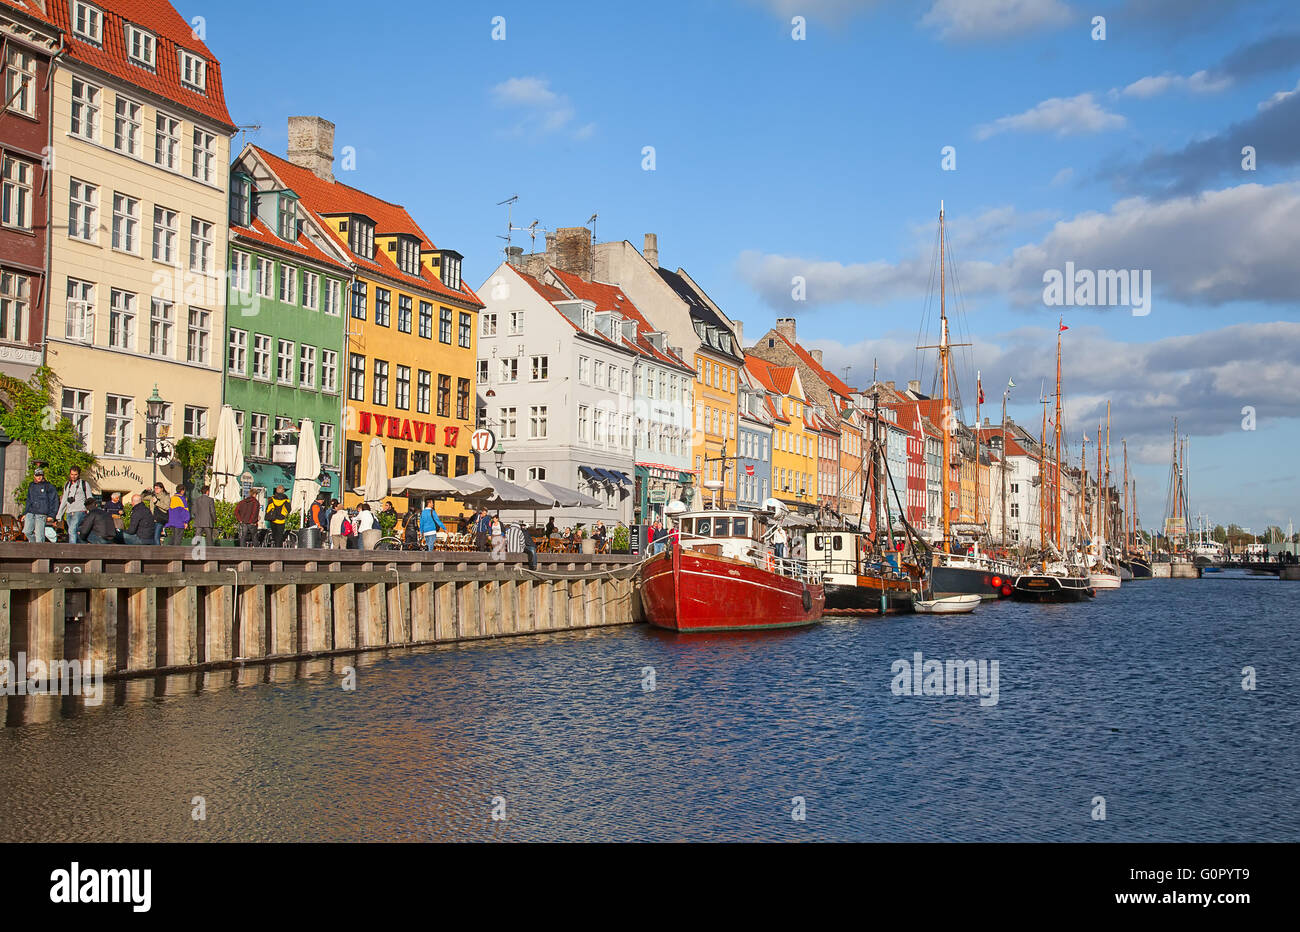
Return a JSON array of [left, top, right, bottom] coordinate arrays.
[[0, 0, 60, 515]]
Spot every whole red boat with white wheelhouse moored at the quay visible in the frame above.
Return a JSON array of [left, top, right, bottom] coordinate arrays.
[[641, 511, 826, 632]]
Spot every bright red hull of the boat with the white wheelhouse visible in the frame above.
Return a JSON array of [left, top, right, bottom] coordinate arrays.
[[641, 547, 826, 632]]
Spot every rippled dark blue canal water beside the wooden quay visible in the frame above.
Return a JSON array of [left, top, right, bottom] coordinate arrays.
[[0, 573, 1300, 841]]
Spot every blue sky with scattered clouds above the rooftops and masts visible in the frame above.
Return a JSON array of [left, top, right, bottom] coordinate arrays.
[[195, 0, 1300, 529]]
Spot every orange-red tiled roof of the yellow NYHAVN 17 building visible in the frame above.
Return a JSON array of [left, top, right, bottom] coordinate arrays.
[[251, 146, 484, 308]]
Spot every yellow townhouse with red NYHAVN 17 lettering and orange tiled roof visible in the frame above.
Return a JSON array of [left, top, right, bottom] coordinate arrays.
[[255, 116, 482, 515]]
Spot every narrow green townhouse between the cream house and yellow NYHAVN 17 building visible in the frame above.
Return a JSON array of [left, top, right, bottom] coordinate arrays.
[[224, 146, 352, 500]]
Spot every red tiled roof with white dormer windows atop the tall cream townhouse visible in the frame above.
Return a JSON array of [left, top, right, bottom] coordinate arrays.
[[19, 0, 235, 133]]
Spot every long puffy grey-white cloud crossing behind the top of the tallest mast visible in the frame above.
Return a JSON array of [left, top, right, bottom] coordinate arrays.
[[737, 182, 1300, 313]]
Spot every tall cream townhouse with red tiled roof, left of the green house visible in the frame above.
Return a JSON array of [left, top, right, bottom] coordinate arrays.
[[43, 0, 235, 491]]
